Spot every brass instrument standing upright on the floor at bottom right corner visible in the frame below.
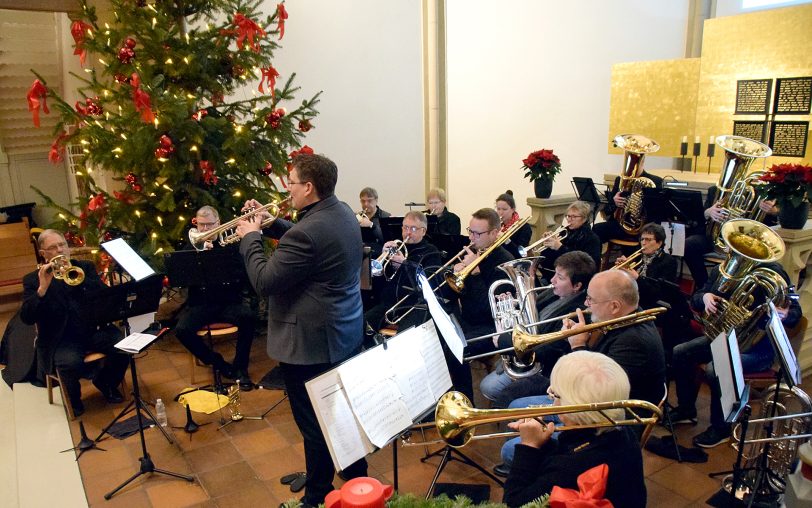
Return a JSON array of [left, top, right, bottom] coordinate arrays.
[[725, 383, 812, 491]]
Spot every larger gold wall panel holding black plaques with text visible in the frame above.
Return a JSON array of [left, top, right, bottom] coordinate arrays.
[[696, 4, 812, 171]]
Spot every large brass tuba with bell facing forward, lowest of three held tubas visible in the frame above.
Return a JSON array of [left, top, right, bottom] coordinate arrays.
[[700, 219, 789, 352]]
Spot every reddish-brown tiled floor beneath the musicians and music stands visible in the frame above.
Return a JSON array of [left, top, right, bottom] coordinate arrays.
[[0, 308, 772, 508]]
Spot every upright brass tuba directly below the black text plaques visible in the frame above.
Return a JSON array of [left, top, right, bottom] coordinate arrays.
[[705, 136, 772, 250]]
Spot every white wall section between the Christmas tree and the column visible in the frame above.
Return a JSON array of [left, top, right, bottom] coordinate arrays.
[[254, 0, 425, 214]]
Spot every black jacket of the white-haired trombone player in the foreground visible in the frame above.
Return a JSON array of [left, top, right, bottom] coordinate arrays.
[[502, 427, 646, 508]]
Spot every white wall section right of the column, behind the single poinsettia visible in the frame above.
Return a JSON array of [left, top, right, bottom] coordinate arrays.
[[446, 0, 688, 222]]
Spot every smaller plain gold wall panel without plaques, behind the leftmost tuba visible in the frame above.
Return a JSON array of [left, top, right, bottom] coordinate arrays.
[[608, 58, 700, 157]]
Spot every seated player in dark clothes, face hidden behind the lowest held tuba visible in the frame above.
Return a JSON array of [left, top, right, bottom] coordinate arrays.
[[671, 263, 802, 448]]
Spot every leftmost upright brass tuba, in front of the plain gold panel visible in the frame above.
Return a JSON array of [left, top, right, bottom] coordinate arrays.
[[613, 134, 660, 235]]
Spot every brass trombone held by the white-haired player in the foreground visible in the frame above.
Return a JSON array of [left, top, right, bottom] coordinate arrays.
[[403, 391, 662, 448]]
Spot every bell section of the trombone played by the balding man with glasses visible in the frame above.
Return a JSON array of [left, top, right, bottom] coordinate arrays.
[[506, 307, 668, 373]]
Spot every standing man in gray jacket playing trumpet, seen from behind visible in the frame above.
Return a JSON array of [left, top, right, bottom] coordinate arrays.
[[237, 154, 367, 506]]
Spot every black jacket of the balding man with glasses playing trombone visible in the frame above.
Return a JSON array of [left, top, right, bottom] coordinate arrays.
[[574, 318, 665, 406]]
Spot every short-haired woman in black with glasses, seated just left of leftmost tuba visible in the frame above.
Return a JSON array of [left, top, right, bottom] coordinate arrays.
[[540, 201, 601, 271]]
